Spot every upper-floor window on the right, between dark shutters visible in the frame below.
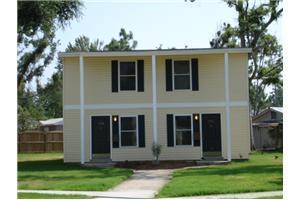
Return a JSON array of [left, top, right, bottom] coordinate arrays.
[[173, 60, 191, 90]]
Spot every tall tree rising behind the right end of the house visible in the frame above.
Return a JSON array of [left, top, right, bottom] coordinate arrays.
[[210, 0, 283, 113]]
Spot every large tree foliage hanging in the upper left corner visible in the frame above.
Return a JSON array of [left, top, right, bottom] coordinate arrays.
[[17, 0, 83, 86]]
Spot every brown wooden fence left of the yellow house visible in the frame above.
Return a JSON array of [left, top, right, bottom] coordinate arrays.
[[18, 130, 63, 153]]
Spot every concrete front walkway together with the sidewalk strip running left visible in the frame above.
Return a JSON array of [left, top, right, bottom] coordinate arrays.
[[18, 169, 173, 199]]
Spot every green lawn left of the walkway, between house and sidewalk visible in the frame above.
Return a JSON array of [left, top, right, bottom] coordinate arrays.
[[18, 153, 133, 191]]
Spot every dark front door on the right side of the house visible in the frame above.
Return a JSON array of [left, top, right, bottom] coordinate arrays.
[[202, 114, 221, 156]]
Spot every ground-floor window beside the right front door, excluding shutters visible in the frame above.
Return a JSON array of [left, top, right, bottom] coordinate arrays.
[[175, 115, 192, 145]]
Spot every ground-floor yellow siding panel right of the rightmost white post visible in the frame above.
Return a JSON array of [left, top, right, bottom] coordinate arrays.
[[231, 107, 250, 159]]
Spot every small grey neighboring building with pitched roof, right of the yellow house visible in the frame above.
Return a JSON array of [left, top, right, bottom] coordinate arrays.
[[252, 107, 283, 150]]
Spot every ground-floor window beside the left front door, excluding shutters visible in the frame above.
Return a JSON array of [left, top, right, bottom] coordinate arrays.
[[120, 117, 137, 146]]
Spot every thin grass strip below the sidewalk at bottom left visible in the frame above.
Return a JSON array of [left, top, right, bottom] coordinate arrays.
[[18, 192, 91, 199]]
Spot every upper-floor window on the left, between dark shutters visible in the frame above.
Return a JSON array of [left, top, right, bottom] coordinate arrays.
[[119, 62, 136, 90]]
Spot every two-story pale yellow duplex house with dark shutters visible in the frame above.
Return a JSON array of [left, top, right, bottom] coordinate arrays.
[[60, 48, 251, 163]]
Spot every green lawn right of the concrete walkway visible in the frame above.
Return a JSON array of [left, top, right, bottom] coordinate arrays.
[[157, 152, 283, 197]]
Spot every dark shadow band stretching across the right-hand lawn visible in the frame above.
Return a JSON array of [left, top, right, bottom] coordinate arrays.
[[175, 165, 282, 177]]
